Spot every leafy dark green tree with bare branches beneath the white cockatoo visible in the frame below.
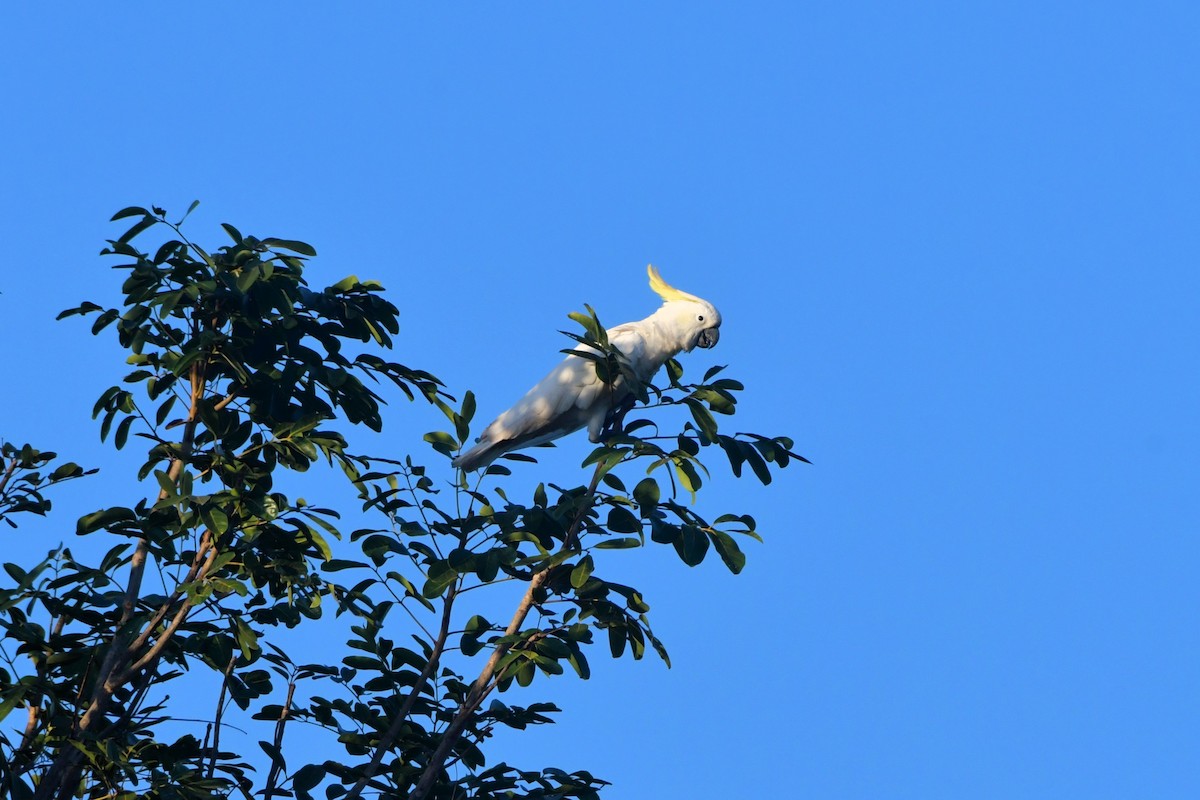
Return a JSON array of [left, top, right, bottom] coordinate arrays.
[[0, 204, 800, 800]]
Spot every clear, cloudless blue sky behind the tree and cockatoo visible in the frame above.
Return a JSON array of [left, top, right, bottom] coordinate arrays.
[[0, 1, 1200, 800]]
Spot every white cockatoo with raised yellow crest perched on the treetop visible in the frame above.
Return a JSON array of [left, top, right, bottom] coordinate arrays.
[[452, 264, 721, 471]]
